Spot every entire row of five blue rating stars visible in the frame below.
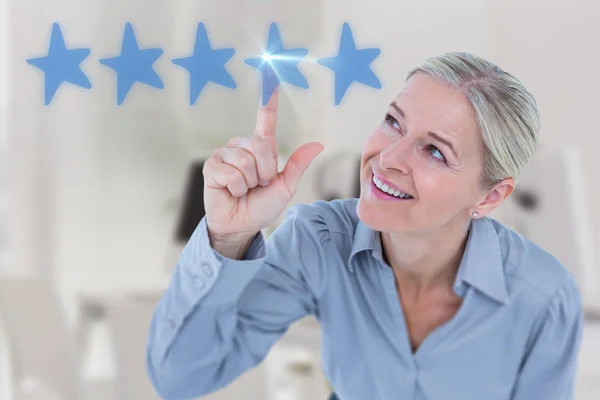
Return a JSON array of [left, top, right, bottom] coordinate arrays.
[[27, 23, 381, 105]]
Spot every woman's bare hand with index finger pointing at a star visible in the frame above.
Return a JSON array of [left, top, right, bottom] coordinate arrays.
[[203, 87, 323, 242]]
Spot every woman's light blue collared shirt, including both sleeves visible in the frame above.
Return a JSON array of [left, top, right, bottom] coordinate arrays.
[[147, 199, 583, 400]]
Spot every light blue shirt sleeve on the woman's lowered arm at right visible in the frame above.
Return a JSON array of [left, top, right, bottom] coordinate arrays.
[[512, 279, 583, 400]]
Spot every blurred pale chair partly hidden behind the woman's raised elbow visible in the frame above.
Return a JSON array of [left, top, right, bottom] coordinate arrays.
[[106, 292, 268, 400]]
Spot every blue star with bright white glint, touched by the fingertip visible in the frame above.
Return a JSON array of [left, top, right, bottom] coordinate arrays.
[[244, 23, 308, 105]]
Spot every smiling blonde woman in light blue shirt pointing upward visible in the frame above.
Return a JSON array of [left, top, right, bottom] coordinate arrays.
[[147, 53, 583, 400]]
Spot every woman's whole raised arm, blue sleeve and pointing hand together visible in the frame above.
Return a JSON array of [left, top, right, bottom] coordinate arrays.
[[147, 85, 327, 400]]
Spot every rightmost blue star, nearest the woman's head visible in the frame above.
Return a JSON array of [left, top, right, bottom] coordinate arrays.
[[317, 22, 381, 105]]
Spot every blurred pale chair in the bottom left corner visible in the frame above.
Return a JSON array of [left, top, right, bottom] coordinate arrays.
[[0, 276, 116, 400]]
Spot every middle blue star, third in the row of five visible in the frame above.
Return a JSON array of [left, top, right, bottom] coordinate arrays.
[[172, 23, 236, 105]]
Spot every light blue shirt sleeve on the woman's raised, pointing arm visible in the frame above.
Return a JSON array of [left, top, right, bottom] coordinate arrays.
[[146, 204, 329, 400]]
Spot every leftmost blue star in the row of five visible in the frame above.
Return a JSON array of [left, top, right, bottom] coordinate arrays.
[[27, 23, 92, 105]]
